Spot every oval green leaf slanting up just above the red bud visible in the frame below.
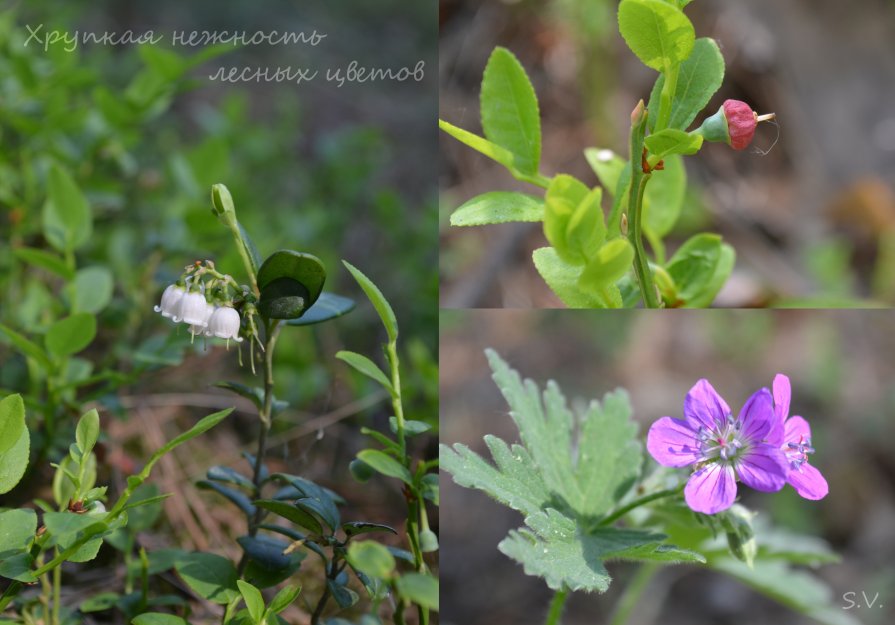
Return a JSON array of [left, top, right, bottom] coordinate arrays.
[[648, 37, 724, 130]]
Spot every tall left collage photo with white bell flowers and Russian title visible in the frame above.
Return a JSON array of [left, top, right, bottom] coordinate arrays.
[[0, 0, 439, 625]]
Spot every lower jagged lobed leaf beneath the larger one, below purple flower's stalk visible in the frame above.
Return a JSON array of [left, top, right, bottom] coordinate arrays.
[[498, 509, 705, 592]]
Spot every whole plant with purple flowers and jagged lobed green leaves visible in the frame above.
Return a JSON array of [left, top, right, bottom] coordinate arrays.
[[440, 350, 855, 625]]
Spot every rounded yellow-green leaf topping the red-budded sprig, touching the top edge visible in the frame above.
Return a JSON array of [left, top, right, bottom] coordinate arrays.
[[618, 0, 696, 72]]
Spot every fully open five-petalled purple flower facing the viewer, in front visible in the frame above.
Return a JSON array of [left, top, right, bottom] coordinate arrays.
[[646, 380, 787, 514]]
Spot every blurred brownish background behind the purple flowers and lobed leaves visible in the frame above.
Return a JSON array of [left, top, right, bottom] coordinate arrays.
[[440, 310, 895, 625]]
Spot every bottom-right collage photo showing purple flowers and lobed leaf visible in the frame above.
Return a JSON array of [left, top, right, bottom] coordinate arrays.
[[440, 310, 895, 625]]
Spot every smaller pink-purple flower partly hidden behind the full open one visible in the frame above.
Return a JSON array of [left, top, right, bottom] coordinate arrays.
[[768, 373, 830, 499]]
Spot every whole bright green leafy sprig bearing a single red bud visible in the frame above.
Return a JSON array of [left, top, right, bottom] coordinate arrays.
[[439, 0, 773, 308]]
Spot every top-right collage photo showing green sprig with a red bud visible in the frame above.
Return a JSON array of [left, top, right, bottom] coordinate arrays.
[[439, 0, 895, 309]]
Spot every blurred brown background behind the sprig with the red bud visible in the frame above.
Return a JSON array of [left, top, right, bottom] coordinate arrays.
[[439, 0, 895, 308]]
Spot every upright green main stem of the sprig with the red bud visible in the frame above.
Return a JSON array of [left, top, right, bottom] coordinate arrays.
[[628, 100, 659, 308]]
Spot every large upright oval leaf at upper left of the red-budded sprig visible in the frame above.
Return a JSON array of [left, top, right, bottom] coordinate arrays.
[[481, 47, 541, 175]]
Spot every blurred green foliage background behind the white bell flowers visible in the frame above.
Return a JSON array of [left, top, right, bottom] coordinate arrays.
[[0, 0, 438, 616]]
